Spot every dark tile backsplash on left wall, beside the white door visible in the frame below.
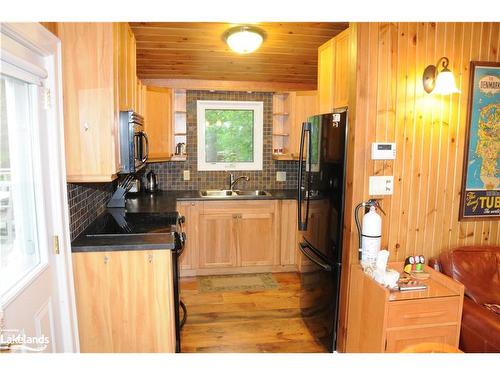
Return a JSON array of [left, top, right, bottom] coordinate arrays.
[[68, 182, 115, 240]]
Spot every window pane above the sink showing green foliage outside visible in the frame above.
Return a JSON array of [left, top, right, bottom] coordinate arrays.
[[205, 109, 254, 163]]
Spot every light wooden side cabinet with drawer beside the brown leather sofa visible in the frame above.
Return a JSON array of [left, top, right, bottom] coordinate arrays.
[[346, 262, 464, 353]]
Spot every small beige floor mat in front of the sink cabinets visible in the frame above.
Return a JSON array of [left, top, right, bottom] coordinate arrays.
[[197, 273, 278, 293]]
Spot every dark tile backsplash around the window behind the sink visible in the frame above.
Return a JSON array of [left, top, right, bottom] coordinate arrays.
[[145, 90, 298, 190]]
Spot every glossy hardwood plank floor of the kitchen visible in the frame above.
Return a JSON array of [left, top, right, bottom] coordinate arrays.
[[181, 273, 325, 353]]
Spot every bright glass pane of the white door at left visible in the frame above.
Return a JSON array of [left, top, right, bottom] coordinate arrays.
[[0, 75, 41, 295]]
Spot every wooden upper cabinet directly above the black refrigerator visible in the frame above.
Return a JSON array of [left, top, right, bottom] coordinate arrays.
[[318, 29, 350, 113]]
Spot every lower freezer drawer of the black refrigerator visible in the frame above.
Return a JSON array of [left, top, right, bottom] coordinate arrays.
[[299, 242, 340, 352]]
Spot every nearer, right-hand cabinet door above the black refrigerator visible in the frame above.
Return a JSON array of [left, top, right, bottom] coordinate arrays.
[[332, 29, 350, 108]]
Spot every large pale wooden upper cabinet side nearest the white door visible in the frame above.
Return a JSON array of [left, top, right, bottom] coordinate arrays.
[[57, 22, 120, 182]]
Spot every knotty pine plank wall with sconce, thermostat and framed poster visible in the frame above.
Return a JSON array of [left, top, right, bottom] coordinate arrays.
[[339, 22, 500, 350]]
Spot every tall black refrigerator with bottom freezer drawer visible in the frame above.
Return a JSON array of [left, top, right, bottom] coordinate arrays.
[[297, 108, 347, 352]]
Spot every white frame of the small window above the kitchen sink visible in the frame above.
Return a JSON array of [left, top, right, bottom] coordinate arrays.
[[196, 100, 264, 171]]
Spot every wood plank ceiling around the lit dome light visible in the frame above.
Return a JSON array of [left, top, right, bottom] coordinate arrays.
[[130, 22, 349, 87]]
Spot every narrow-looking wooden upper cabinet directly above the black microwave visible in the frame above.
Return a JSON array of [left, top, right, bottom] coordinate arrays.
[[117, 22, 138, 112]]
